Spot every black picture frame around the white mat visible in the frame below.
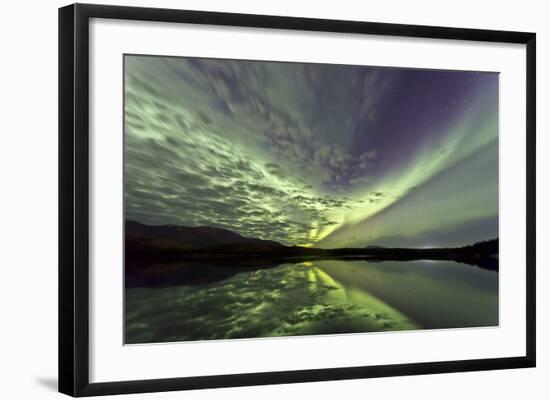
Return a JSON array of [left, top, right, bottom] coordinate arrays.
[[59, 4, 536, 396]]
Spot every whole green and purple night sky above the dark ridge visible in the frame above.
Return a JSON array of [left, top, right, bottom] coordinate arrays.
[[125, 56, 498, 248]]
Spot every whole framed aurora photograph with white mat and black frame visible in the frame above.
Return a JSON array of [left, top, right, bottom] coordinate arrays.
[[59, 4, 536, 396]]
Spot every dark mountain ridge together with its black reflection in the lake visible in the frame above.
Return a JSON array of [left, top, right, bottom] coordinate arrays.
[[125, 221, 498, 287]]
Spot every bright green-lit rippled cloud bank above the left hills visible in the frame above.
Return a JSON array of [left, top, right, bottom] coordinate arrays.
[[125, 122, 362, 244]]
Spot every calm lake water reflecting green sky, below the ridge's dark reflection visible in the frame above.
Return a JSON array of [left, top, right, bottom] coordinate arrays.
[[126, 261, 498, 343]]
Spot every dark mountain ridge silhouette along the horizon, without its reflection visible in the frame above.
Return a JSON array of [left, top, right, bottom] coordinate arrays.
[[126, 221, 498, 265]]
